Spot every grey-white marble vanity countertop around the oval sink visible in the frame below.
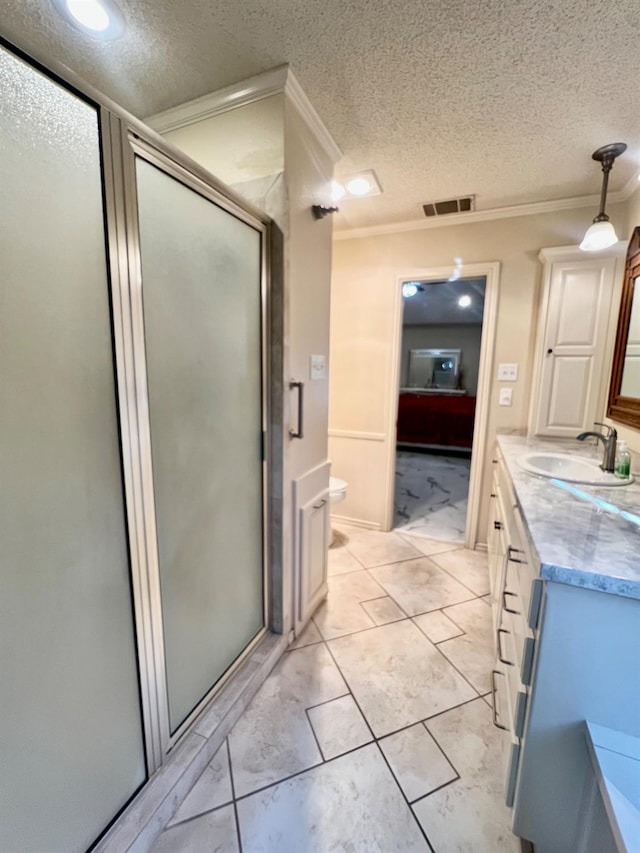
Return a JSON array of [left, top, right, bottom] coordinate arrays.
[[498, 435, 640, 599]]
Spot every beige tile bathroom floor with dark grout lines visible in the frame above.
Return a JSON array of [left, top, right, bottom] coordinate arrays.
[[153, 526, 520, 853]]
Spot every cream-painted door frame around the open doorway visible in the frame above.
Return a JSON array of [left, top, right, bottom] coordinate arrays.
[[385, 261, 500, 548]]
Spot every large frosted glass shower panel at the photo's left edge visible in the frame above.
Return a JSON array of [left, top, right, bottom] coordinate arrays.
[[0, 48, 146, 853]]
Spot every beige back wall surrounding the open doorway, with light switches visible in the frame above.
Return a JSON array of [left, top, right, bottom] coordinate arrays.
[[329, 204, 626, 542]]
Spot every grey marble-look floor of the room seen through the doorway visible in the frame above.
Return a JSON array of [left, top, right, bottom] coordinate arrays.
[[394, 450, 471, 542]]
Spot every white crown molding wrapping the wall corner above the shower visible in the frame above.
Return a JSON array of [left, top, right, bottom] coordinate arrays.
[[145, 65, 342, 163]]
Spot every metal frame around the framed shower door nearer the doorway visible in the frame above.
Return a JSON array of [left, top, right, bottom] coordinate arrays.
[[101, 115, 270, 772]]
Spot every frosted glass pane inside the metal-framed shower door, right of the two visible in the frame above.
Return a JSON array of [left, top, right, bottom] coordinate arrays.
[[136, 157, 265, 732]]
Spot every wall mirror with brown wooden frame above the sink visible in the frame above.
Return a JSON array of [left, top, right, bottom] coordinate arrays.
[[607, 226, 640, 428]]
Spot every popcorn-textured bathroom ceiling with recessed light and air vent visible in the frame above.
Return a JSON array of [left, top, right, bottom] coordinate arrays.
[[0, 0, 640, 228]]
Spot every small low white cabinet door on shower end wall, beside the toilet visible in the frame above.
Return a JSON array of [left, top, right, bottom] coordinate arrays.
[[296, 492, 329, 629]]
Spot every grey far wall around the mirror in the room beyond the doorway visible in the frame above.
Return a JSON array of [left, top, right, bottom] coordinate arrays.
[[400, 323, 482, 395]]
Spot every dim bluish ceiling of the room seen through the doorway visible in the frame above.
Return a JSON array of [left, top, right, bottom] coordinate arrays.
[[402, 278, 486, 326]]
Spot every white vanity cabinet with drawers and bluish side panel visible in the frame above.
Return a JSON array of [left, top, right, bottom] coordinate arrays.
[[488, 442, 640, 853]]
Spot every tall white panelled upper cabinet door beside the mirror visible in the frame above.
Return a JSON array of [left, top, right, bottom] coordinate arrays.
[[533, 251, 616, 438]]
